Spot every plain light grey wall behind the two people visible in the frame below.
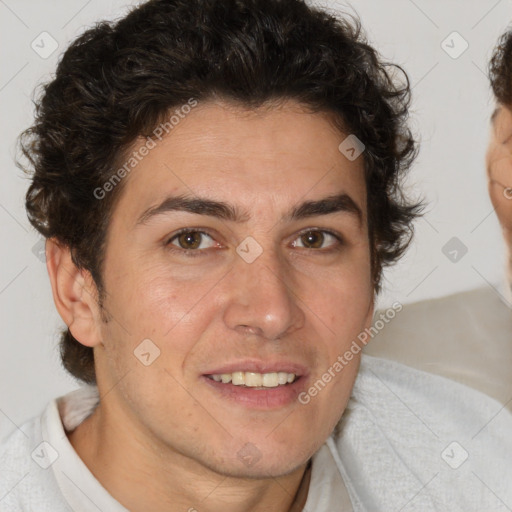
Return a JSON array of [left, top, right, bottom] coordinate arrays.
[[0, 0, 512, 438]]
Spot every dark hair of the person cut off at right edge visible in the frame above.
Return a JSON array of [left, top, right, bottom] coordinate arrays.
[[489, 28, 512, 107]]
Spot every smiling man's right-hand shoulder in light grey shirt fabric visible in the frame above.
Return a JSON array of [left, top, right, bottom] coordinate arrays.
[[333, 356, 512, 511]]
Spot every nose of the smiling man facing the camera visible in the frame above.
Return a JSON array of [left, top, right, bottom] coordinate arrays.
[[224, 250, 305, 340]]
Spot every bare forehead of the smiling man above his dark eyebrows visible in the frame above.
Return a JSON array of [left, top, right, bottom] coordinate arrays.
[[113, 102, 366, 225]]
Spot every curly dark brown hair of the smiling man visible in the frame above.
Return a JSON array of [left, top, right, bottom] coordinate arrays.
[[18, 0, 421, 383]]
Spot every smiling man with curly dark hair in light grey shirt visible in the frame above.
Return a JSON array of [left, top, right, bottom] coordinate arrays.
[[0, 0, 512, 512]]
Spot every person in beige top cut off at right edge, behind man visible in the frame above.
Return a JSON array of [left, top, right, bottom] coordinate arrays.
[[365, 30, 512, 410]]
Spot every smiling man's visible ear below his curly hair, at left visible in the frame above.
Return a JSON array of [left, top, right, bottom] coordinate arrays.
[[46, 239, 101, 347]]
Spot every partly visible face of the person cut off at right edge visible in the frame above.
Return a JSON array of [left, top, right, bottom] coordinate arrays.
[[486, 106, 512, 238]]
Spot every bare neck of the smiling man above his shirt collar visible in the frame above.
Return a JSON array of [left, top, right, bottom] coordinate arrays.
[[68, 404, 310, 512]]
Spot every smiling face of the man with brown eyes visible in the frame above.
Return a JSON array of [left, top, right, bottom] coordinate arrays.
[[91, 99, 373, 477]]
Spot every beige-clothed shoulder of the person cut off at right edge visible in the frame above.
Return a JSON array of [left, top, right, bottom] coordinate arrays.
[[364, 287, 512, 411]]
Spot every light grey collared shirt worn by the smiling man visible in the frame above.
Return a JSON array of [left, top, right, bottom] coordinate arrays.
[[0, 355, 512, 512]]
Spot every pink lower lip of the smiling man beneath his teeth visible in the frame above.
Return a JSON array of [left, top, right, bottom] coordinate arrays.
[[201, 375, 306, 410]]
